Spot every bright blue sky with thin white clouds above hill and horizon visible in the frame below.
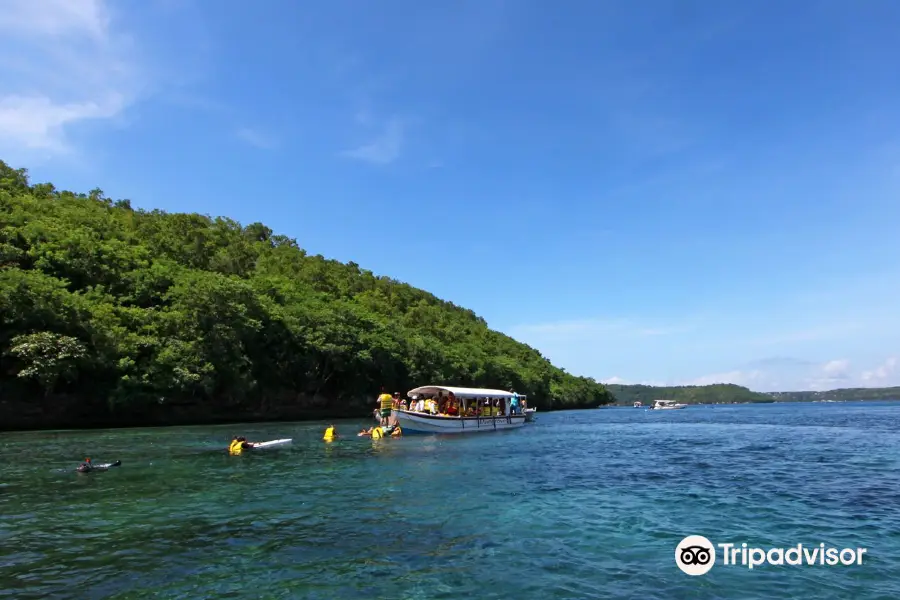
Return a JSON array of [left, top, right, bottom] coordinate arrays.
[[0, 0, 900, 390]]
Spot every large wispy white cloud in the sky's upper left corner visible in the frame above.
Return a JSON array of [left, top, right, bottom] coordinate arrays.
[[0, 0, 139, 160]]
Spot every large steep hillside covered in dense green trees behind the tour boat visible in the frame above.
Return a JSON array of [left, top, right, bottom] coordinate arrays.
[[0, 161, 613, 427]]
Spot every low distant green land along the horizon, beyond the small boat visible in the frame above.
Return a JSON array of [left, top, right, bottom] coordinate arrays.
[[606, 383, 900, 405]]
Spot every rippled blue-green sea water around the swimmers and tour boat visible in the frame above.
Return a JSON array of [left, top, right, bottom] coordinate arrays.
[[0, 403, 900, 600]]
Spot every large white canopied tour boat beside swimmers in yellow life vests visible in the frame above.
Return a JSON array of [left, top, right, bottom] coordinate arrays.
[[391, 385, 533, 433]]
